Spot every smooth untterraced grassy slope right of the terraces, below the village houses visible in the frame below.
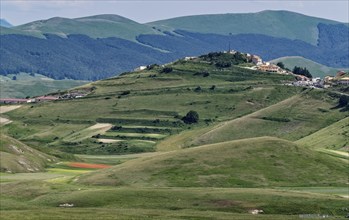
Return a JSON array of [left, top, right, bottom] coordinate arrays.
[[190, 91, 349, 145]]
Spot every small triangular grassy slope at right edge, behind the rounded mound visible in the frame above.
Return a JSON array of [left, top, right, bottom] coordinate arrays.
[[297, 117, 349, 150]]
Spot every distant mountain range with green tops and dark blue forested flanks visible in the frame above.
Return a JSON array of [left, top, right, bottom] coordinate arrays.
[[0, 11, 349, 80]]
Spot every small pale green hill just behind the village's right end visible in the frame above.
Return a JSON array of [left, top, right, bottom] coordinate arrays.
[[270, 56, 339, 78]]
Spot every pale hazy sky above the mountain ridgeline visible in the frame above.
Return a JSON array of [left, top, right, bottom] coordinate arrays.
[[0, 0, 349, 25]]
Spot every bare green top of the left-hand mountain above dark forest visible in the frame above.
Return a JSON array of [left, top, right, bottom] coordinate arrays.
[[5, 15, 160, 41]]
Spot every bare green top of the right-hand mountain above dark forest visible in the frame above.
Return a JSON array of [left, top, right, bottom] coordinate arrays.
[[149, 11, 338, 45]]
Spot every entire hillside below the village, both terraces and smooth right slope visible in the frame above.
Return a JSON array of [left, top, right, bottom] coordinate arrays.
[[4, 55, 348, 154]]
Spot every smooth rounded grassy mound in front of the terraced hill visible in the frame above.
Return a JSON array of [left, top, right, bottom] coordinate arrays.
[[79, 137, 349, 187]]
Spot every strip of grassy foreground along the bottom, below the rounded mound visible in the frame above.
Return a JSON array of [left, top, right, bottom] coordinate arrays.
[[1, 181, 346, 219]]
